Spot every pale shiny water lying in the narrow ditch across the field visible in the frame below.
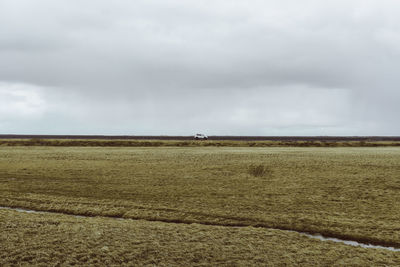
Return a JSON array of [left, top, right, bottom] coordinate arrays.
[[0, 207, 400, 251]]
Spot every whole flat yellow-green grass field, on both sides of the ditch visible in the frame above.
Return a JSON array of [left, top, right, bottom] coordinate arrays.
[[0, 146, 400, 266]]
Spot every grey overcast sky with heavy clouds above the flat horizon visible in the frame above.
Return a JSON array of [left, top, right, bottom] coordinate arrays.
[[0, 0, 400, 135]]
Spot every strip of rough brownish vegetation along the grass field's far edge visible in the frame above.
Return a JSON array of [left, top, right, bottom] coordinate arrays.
[[0, 138, 400, 147]]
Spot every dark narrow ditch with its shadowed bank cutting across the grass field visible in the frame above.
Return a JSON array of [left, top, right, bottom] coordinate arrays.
[[0, 206, 400, 251]]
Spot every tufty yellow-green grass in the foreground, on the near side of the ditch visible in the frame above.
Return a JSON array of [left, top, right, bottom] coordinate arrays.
[[0, 210, 400, 266]]
